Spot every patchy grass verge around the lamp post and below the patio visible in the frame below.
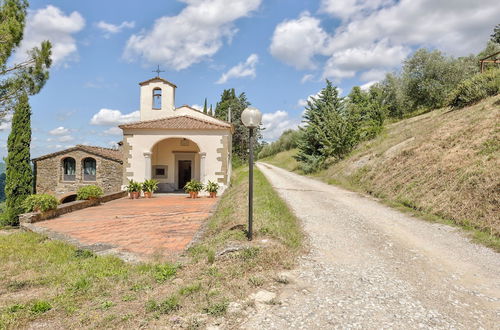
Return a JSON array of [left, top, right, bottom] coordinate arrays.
[[0, 168, 302, 329]]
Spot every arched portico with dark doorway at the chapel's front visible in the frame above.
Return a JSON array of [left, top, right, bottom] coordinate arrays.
[[144, 137, 205, 192]]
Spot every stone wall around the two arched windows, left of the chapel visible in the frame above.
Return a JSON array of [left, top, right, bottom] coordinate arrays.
[[36, 150, 123, 199]]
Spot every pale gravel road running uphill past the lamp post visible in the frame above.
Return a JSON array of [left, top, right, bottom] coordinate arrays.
[[242, 163, 500, 329]]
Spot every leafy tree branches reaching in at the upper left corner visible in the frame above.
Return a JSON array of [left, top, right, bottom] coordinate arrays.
[[0, 0, 51, 118]]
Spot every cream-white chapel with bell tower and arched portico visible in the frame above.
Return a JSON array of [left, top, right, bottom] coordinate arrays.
[[119, 77, 233, 192]]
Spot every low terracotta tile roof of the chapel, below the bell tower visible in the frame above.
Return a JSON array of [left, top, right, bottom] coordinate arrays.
[[118, 115, 233, 130]]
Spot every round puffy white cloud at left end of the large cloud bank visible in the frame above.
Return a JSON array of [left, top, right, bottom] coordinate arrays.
[[269, 12, 329, 69]]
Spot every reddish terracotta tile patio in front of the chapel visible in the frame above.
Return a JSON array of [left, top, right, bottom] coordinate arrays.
[[34, 195, 217, 257]]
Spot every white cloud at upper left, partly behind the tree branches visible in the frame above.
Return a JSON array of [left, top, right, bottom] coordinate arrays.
[[14, 5, 85, 65]]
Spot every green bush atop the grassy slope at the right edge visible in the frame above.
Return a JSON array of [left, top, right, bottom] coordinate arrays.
[[448, 69, 500, 109]]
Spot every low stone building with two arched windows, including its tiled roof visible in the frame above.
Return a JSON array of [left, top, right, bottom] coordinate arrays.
[[33, 145, 123, 202]]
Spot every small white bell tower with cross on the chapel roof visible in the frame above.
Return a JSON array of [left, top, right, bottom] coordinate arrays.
[[139, 67, 177, 121]]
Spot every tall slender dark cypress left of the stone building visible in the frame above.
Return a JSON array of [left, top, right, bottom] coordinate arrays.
[[4, 93, 33, 226]]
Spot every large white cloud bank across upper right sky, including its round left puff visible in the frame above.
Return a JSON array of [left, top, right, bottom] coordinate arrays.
[[271, 0, 500, 81]]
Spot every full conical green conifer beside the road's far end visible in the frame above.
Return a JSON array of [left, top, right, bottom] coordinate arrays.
[[295, 80, 359, 172]]
